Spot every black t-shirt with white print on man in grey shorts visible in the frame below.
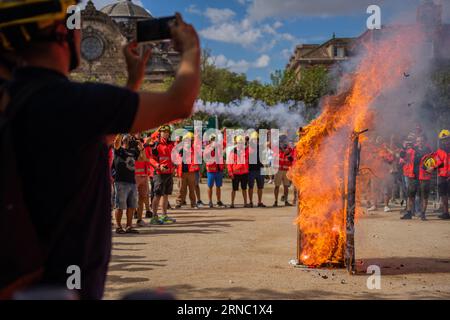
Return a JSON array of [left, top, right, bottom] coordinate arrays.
[[114, 148, 140, 184]]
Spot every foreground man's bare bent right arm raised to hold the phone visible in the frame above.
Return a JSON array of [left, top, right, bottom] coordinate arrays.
[[129, 14, 200, 132]]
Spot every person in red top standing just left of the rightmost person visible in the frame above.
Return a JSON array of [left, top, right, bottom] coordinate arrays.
[[400, 136, 431, 220]]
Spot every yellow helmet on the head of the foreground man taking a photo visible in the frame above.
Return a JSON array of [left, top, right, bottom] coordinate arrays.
[[0, 0, 80, 51]]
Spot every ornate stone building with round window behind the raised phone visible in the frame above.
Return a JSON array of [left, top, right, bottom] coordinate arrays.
[[72, 0, 180, 84]]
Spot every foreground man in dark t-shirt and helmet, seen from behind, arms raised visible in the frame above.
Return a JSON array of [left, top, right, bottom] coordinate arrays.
[[0, 0, 200, 299]]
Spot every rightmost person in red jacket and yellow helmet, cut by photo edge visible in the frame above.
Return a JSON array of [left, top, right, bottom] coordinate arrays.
[[429, 130, 450, 220]]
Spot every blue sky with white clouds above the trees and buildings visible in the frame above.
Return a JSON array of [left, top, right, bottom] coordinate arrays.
[[86, 0, 450, 82]]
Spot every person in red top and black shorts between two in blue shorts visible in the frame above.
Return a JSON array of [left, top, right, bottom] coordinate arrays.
[[227, 136, 250, 208]]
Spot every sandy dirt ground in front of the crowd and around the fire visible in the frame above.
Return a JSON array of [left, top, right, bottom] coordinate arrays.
[[105, 183, 450, 299]]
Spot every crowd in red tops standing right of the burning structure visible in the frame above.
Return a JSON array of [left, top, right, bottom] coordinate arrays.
[[366, 125, 450, 221]]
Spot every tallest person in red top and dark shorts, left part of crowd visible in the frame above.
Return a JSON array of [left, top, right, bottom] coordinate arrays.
[[150, 125, 176, 224]]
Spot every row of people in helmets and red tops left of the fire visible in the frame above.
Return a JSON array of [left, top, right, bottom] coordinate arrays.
[[109, 125, 295, 234]]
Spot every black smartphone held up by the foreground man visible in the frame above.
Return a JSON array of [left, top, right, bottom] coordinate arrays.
[[136, 16, 176, 42]]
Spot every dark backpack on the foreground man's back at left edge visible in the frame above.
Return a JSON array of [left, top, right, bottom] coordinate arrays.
[[0, 79, 49, 300]]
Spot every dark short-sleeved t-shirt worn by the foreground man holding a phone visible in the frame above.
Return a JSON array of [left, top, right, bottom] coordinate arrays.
[[9, 68, 139, 299]]
